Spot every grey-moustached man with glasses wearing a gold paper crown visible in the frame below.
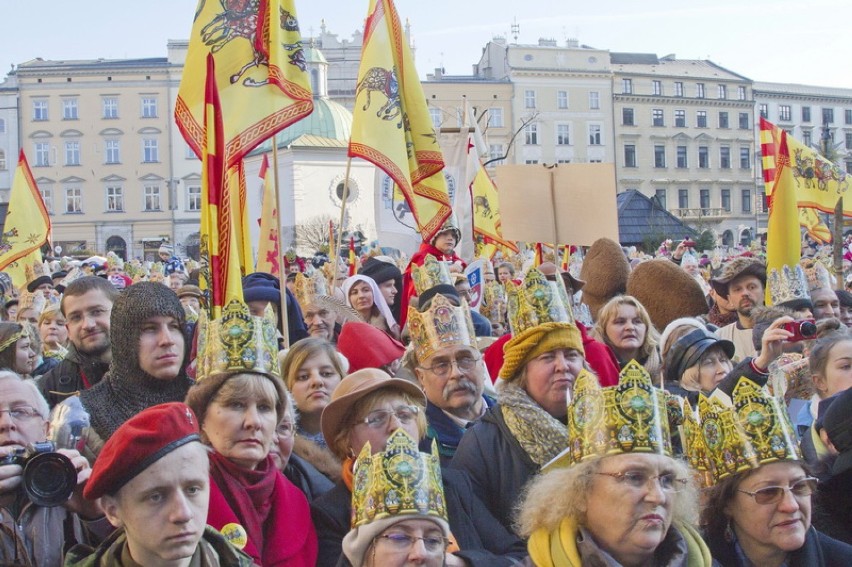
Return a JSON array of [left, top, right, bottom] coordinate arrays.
[[408, 285, 495, 465]]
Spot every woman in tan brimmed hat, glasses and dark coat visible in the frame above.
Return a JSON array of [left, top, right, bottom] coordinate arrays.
[[311, 368, 526, 567]]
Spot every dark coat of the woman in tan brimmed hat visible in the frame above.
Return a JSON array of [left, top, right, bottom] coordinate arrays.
[[311, 469, 527, 567]]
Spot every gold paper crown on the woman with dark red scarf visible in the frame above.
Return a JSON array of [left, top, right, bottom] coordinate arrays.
[[195, 300, 281, 382]]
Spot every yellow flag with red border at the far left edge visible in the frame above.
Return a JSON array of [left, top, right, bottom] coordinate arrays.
[[0, 150, 50, 286]]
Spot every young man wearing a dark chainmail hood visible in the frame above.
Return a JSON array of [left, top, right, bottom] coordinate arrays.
[[80, 282, 190, 455]]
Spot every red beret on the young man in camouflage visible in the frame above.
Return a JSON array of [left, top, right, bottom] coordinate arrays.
[[83, 402, 201, 500]]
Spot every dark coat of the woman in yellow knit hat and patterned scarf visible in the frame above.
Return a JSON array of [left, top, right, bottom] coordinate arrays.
[[450, 403, 540, 533]]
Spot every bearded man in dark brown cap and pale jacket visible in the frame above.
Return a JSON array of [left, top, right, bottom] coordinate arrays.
[[710, 257, 766, 362]]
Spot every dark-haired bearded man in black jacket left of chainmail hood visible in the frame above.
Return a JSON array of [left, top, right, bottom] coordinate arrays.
[[39, 276, 118, 409]]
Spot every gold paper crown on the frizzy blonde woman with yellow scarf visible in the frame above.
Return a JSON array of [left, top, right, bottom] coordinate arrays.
[[560, 360, 672, 465]]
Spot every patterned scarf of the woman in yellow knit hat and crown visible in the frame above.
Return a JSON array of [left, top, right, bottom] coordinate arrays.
[[498, 382, 568, 467]]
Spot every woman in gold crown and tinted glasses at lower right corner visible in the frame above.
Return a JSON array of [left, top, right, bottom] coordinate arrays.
[[686, 378, 852, 567]]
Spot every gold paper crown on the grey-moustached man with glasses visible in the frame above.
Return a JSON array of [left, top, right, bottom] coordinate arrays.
[[408, 293, 476, 362]]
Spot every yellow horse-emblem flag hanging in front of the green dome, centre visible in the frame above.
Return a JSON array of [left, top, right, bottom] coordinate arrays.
[[349, 0, 450, 242]]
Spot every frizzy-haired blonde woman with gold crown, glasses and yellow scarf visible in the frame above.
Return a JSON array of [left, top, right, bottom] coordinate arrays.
[[518, 361, 713, 567]]
